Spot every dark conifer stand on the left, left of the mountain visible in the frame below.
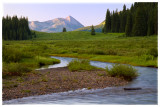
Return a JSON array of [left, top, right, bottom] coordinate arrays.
[[2, 15, 36, 40]]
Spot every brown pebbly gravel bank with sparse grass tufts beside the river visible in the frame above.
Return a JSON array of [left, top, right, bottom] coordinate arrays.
[[2, 67, 128, 100]]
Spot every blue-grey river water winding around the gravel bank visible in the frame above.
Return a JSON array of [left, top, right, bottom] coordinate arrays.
[[3, 56, 158, 105]]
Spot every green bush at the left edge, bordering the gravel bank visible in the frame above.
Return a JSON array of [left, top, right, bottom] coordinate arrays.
[[2, 63, 31, 78]]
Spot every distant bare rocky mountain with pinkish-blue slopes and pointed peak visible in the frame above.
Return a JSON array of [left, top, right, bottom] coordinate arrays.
[[29, 16, 84, 32]]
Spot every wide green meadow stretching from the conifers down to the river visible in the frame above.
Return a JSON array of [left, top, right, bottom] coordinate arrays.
[[3, 31, 158, 77]]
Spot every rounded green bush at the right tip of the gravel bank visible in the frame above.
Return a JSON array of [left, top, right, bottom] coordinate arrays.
[[106, 64, 138, 81]]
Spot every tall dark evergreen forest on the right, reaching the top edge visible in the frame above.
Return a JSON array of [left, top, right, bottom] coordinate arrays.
[[102, 2, 158, 36]]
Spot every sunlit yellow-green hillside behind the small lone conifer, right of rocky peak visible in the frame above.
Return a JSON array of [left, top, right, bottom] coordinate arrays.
[[75, 21, 105, 32]]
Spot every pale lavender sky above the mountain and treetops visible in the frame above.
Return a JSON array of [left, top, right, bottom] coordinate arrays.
[[3, 3, 132, 26]]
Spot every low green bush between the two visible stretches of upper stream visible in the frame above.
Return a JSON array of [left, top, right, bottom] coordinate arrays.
[[68, 59, 97, 72]]
